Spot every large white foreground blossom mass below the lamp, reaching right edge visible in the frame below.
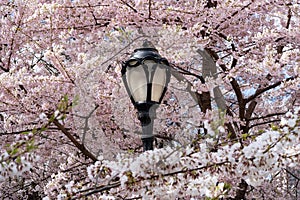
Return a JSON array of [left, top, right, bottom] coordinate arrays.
[[43, 110, 300, 199]]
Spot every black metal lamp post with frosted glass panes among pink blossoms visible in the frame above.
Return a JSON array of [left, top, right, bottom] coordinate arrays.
[[122, 41, 170, 151]]
